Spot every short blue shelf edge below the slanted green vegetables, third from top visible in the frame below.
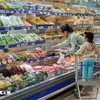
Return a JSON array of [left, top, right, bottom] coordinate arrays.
[[0, 40, 45, 50]]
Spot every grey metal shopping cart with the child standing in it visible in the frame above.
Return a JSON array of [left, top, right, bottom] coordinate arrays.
[[75, 55, 100, 100]]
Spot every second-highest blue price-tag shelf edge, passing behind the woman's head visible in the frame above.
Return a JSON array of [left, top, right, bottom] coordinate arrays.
[[0, 24, 100, 31]]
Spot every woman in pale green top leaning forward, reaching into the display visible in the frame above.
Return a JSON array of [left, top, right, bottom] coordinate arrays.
[[51, 24, 84, 54]]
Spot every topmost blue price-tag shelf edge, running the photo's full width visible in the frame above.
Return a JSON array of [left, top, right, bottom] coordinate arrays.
[[0, 10, 100, 17]]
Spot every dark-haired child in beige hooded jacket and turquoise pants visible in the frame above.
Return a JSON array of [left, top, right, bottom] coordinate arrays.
[[75, 32, 100, 80]]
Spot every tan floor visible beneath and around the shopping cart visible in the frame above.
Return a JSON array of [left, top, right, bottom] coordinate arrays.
[[53, 87, 100, 100]]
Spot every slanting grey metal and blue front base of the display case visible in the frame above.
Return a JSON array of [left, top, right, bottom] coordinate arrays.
[[0, 71, 75, 100]]
